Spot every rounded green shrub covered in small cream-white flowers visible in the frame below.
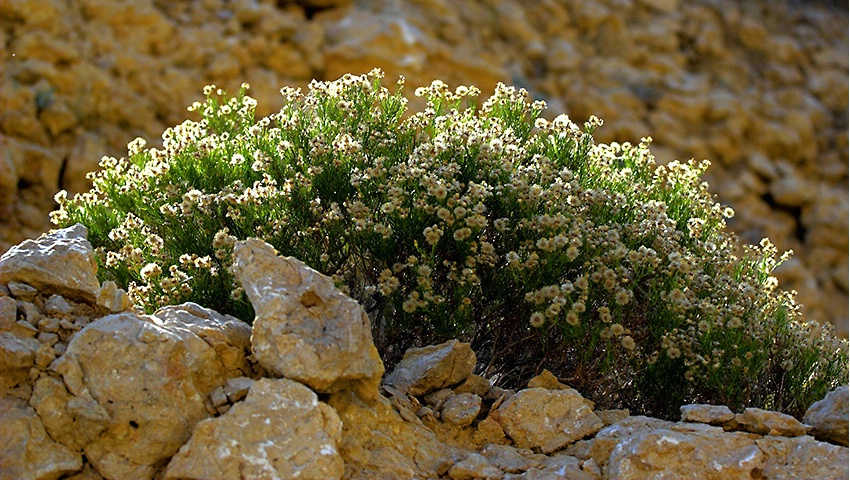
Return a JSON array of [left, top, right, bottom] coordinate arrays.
[[52, 71, 848, 417]]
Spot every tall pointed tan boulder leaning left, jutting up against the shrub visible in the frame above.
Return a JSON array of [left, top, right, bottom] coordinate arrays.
[[233, 239, 384, 400]]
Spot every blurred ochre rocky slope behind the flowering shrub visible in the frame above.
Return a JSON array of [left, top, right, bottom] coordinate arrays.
[[0, 0, 848, 337]]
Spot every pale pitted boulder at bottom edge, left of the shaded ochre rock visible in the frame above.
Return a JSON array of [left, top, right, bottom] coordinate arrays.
[[164, 378, 343, 480]]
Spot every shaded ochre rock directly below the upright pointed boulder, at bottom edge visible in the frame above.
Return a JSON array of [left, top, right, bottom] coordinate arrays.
[[328, 392, 456, 480]]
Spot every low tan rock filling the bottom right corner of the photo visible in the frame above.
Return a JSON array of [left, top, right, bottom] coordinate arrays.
[[756, 436, 850, 480]]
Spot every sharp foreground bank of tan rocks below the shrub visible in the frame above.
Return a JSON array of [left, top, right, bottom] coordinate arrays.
[[0, 225, 848, 480]]
